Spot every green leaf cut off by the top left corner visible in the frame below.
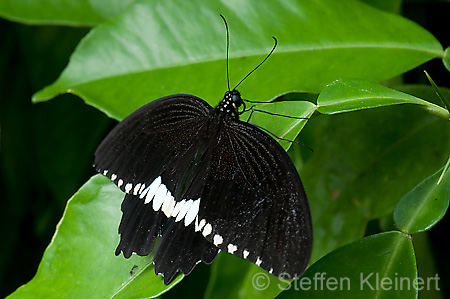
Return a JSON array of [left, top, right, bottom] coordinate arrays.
[[0, 0, 133, 27]]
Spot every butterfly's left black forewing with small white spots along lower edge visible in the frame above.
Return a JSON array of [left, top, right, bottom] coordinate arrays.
[[94, 94, 212, 198]]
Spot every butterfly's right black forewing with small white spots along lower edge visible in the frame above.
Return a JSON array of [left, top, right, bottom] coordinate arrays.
[[199, 121, 312, 278]]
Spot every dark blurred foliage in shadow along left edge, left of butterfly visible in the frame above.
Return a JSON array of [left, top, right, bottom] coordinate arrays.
[[0, 20, 112, 297]]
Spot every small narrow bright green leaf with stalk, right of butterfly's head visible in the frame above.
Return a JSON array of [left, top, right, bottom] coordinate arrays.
[[317, 79, 450, 120]]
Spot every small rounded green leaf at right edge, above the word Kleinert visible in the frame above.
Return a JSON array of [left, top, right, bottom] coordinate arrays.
[[394, 169, 450, 234]]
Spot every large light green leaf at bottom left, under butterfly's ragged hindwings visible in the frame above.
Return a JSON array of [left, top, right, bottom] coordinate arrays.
[[8, 175, 182, 299]]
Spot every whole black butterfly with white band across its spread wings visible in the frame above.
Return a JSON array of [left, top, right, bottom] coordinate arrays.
[[95, 15, 312, 284]]
